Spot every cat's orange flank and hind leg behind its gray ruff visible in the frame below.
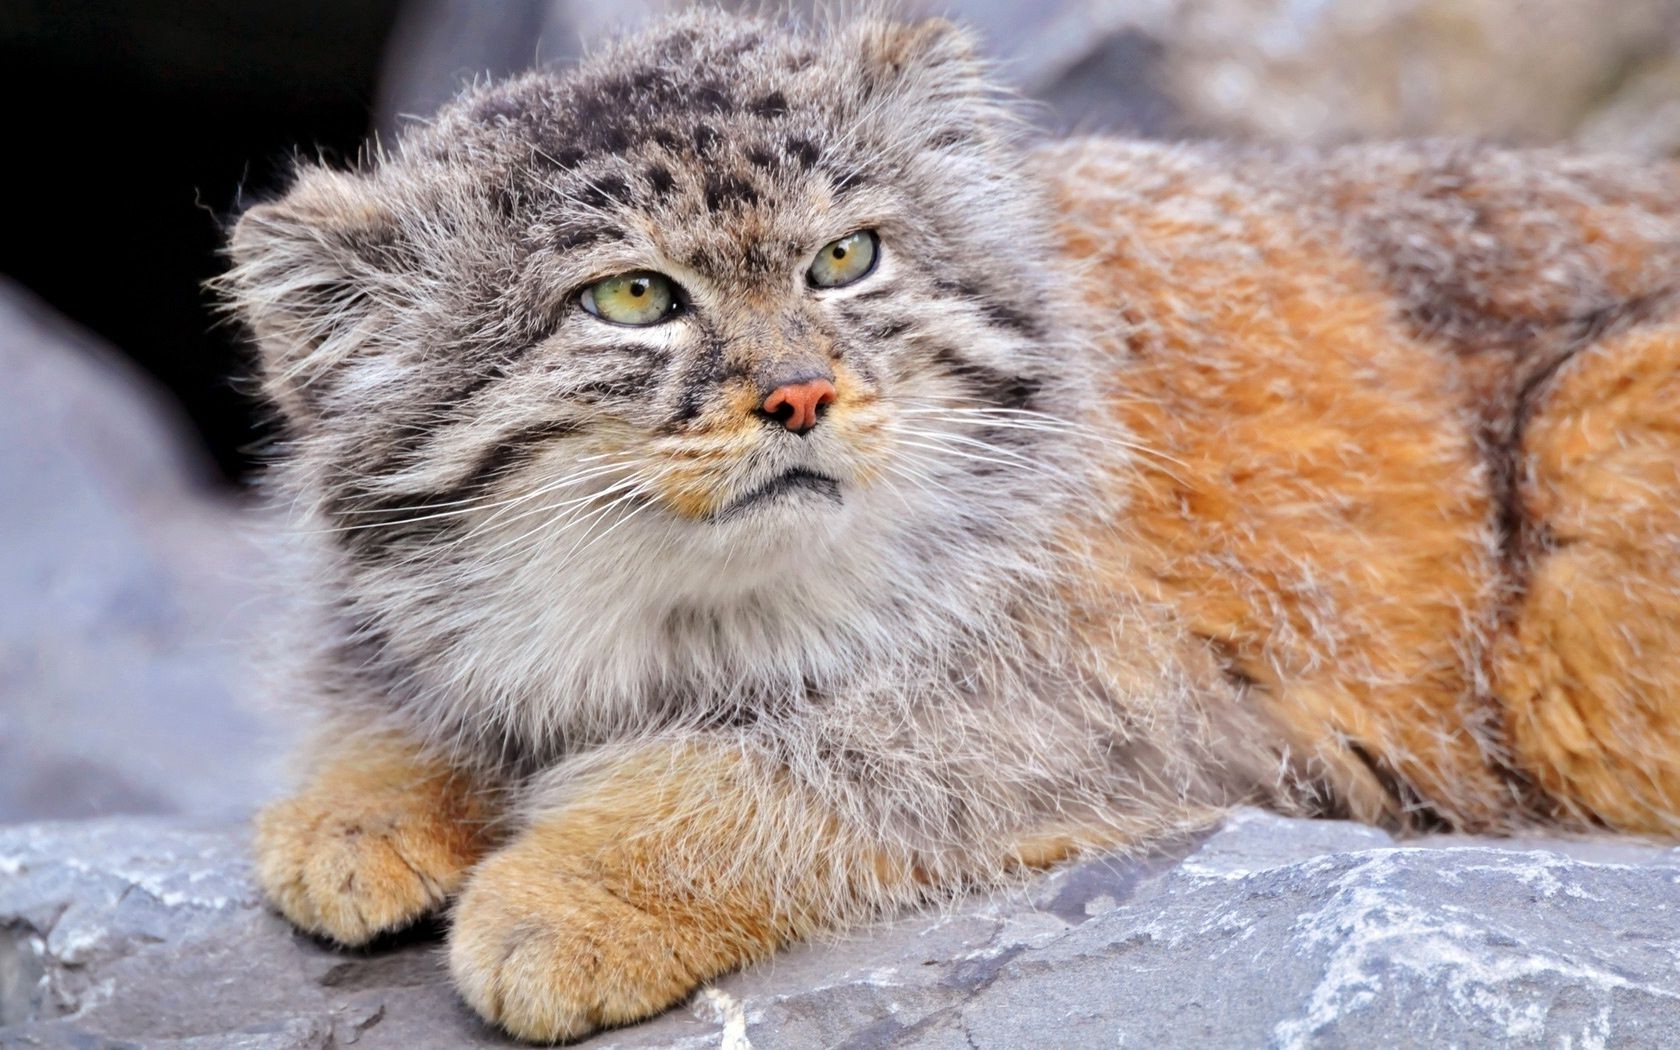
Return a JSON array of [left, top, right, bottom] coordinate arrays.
[[1045, 135, 1680, 833]]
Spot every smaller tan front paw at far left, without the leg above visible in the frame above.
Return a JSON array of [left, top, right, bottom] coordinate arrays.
[[254, 793, 482, 946]]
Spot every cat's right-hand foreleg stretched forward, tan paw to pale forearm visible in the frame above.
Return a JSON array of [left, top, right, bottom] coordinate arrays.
[[450, 738, 917, 1040]]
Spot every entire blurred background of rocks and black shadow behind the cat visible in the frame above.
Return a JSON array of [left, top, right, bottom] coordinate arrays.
[[0, 0, 1680, 823]]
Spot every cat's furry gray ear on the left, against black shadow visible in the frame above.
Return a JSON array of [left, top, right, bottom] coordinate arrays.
[[215, 166, 402, 420]]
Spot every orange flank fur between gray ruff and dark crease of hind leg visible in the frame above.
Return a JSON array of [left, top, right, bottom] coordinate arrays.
[[1058, 141, 1507, 825]]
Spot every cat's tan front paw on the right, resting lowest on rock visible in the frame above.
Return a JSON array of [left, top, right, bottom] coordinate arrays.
[[449, 842, 763, 1042]]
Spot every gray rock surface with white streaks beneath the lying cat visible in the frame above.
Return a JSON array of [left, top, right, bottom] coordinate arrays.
[[0, 811, 1680, 1050]]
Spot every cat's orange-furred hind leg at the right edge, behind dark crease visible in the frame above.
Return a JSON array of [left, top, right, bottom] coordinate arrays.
[[1494, 324, 1680, 835]]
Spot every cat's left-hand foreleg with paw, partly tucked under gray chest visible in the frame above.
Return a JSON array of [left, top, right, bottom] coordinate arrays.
[[254, 732, 492, 944]]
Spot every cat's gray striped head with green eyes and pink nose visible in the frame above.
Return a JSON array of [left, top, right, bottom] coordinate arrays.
[[225, 12, 1079, 631]]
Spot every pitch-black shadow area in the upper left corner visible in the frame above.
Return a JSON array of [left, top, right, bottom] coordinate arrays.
[[0, 0, 400, 480]]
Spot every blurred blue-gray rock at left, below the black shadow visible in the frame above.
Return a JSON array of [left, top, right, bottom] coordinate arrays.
[[0, 284, 284, 823]]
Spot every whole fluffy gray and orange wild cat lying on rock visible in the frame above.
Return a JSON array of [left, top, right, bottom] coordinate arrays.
[[220, 10, 1680, 1040]]
